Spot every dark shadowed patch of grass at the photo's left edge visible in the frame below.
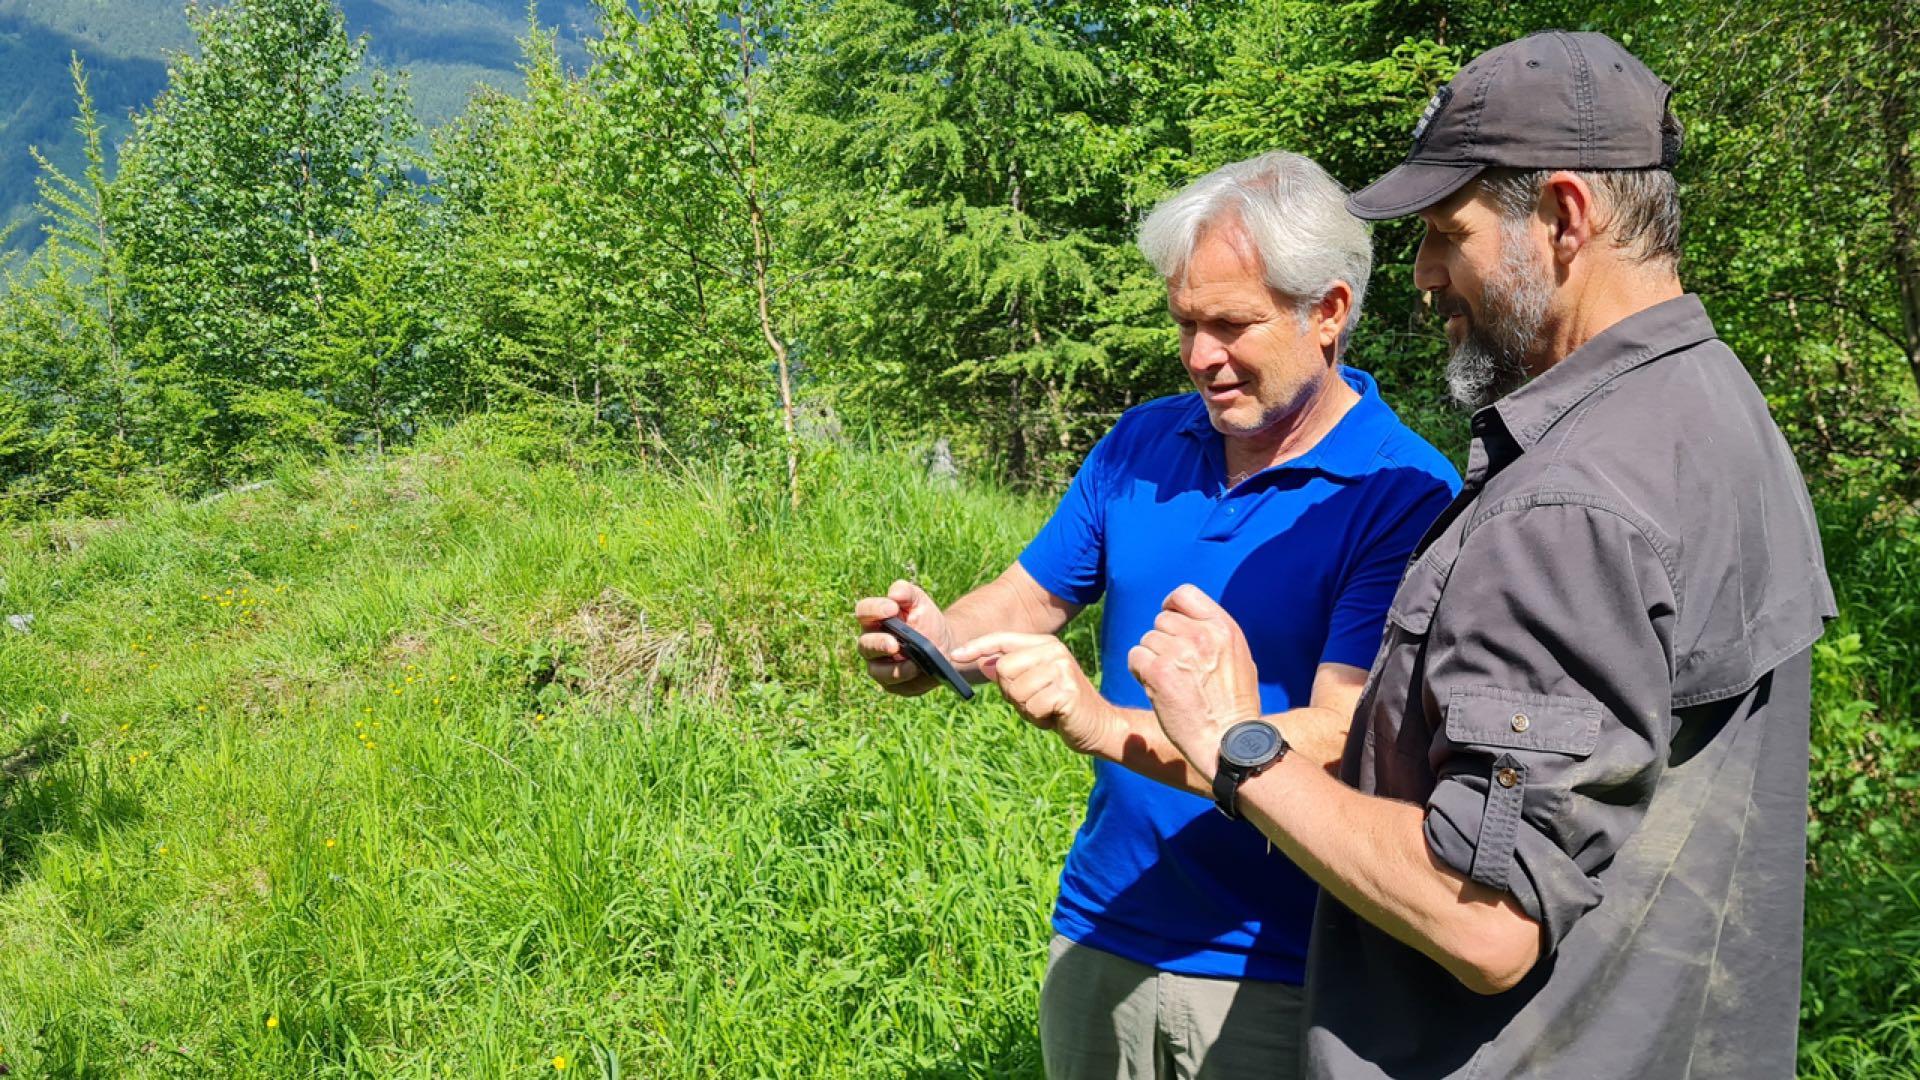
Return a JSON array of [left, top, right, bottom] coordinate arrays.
[[0, 721, 142, 892]]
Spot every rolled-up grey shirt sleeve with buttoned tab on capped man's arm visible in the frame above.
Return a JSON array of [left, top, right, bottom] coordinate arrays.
[[1427, 502, 1674, 949]]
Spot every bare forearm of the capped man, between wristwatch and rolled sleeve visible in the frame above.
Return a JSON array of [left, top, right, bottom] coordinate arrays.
[[1240, 745, 1540, 994]]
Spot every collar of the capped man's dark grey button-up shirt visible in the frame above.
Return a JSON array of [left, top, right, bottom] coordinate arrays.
[[1473, 292, 1718, 454]]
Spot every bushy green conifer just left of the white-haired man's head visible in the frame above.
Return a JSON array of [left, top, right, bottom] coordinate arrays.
[[781, 0, 1210, 480]]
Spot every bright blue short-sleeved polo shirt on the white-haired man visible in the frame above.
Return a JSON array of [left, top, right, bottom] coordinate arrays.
[[1020, 367, 1459, 984]]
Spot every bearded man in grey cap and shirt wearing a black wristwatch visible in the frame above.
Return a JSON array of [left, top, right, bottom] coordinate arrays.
[[1129, 31, 1834, 1078]]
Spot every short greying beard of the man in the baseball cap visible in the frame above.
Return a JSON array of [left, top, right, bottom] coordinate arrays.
[[1446, 221, 1553, 411]]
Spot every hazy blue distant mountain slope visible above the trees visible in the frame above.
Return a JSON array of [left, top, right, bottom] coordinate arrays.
[[0, 0, 593, 250]]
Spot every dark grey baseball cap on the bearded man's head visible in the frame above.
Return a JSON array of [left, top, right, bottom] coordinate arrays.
[[1346, 31, 1680, 221]]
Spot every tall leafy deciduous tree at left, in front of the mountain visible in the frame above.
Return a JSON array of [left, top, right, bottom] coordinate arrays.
[[111, 0, 433, 482]]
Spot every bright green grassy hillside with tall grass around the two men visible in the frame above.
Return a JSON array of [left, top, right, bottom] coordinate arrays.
[[0, 430, 1920, 1078]]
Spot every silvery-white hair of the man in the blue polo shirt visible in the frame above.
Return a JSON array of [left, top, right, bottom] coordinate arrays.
[[1139, 150, 1373, 336]]
